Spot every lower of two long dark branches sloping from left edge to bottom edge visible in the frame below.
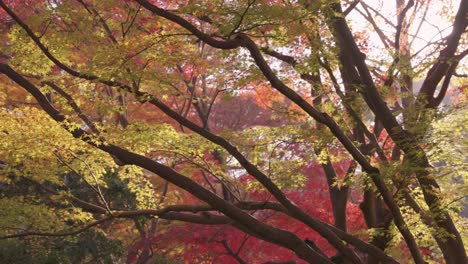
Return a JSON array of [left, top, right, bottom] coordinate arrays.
[[0, 64, 331, 263]]
